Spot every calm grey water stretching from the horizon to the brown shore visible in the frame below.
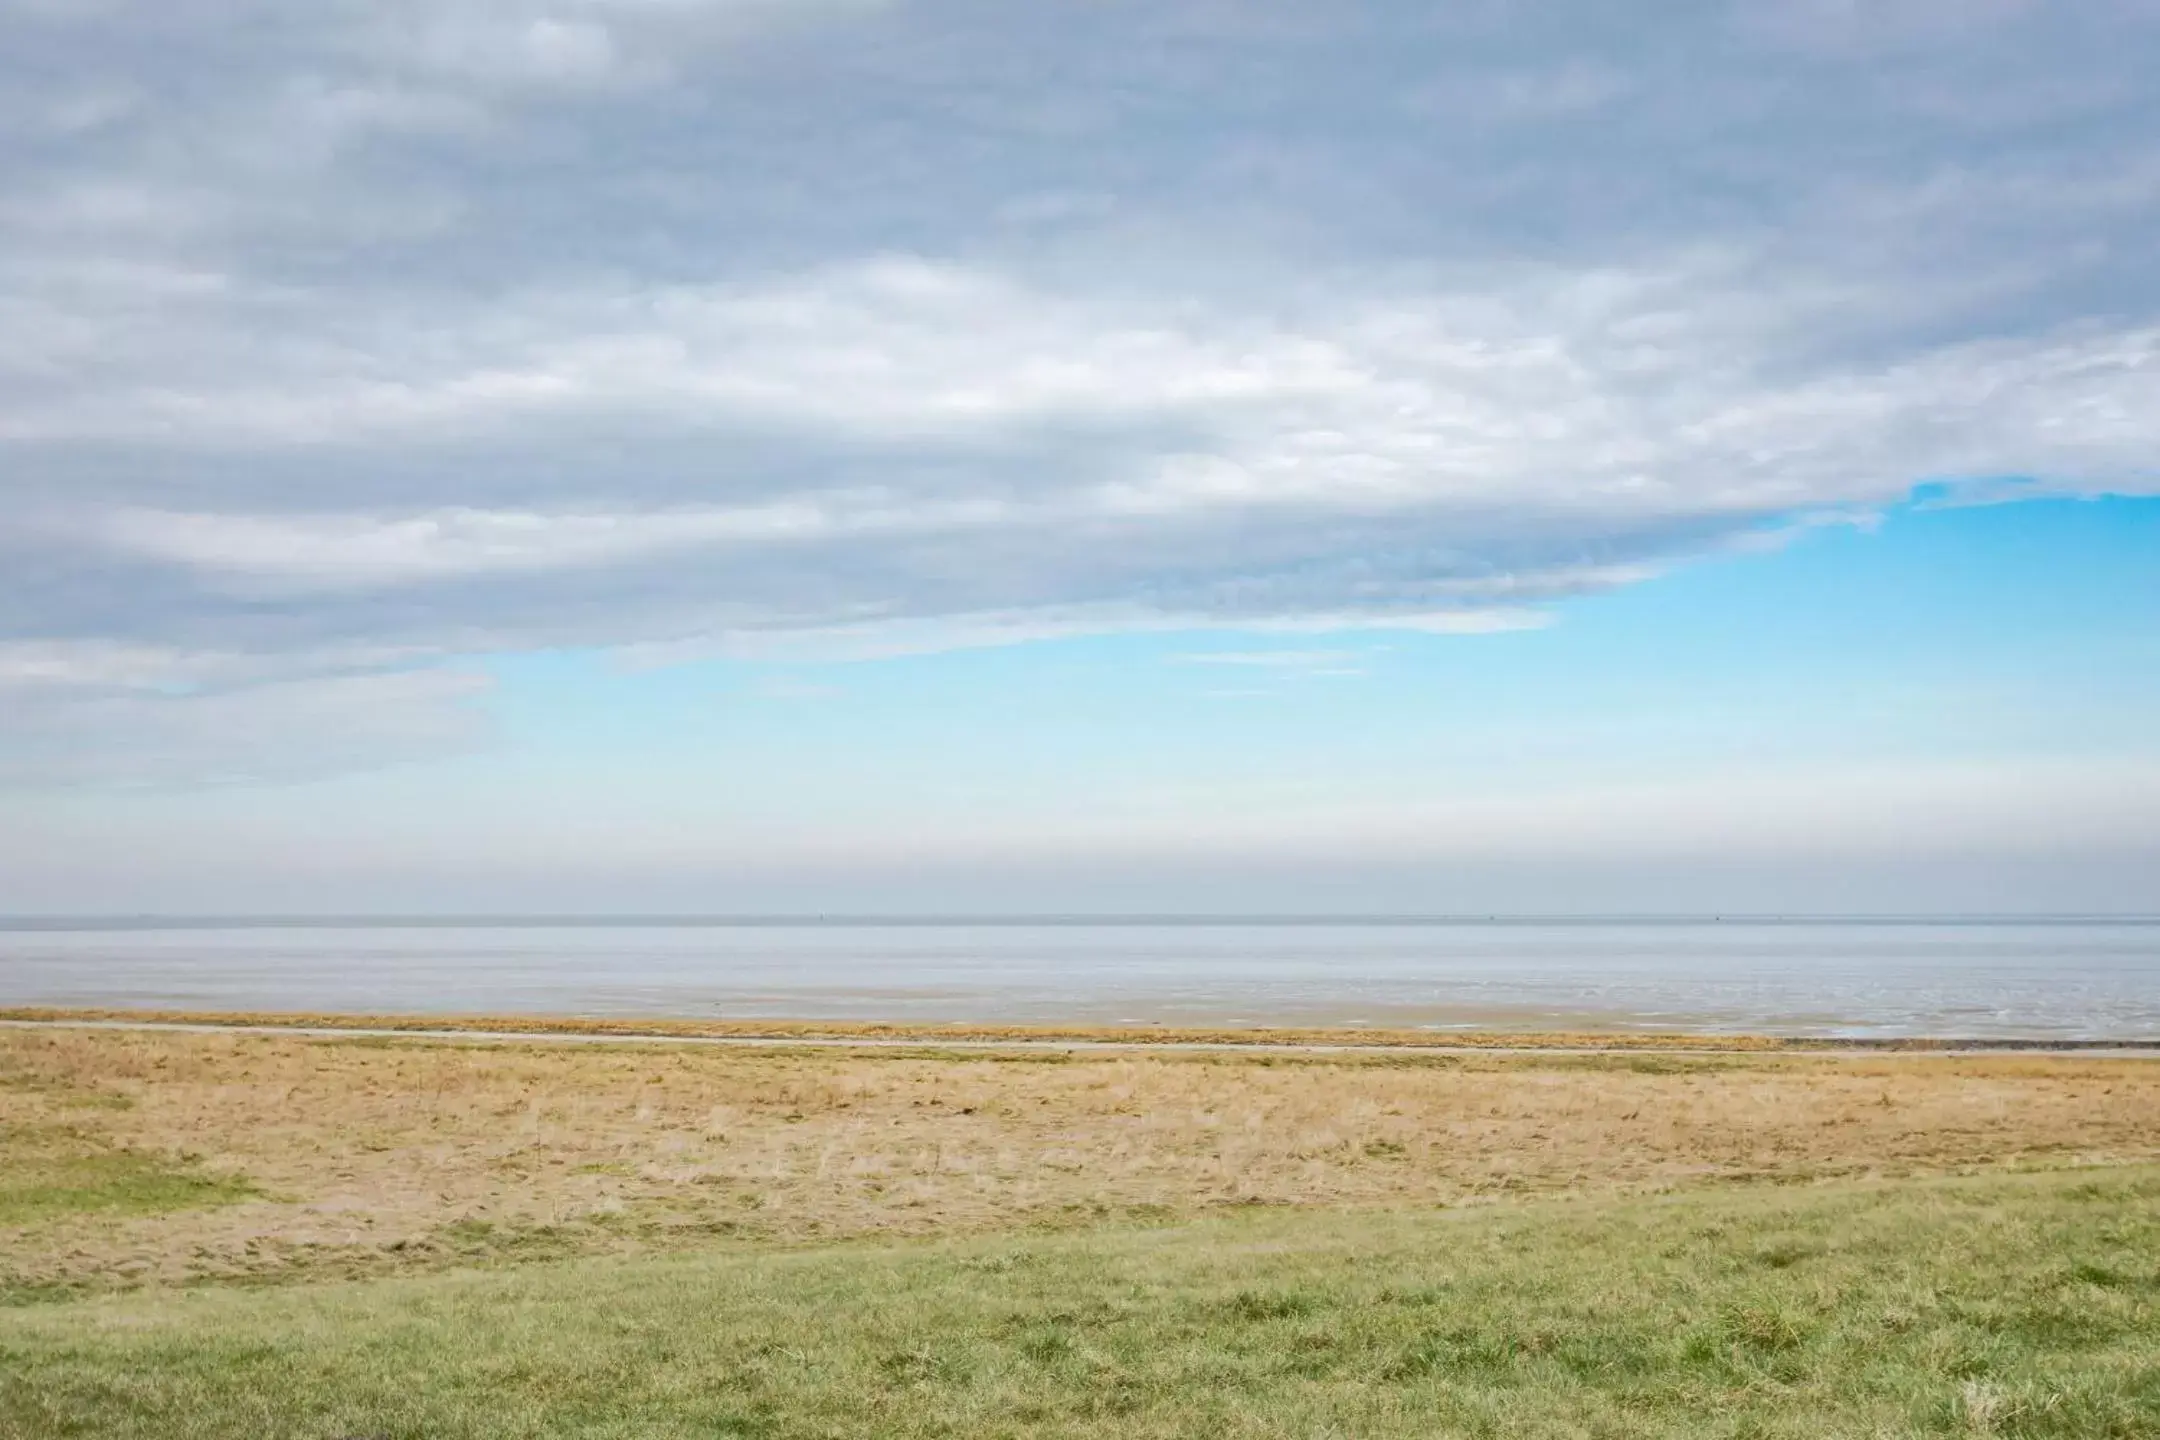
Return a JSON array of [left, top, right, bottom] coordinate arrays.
[[0, 920, 2160, 1038]]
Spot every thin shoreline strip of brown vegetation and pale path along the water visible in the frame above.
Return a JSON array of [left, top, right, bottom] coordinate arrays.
[[0, 1006, 2160, 1058]]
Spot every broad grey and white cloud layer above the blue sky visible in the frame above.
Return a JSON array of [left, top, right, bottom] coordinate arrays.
[[0, 0, 2160, 775]]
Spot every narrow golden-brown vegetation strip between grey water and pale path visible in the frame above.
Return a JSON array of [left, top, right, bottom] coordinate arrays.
[[0, 1006, 2160, 1054]]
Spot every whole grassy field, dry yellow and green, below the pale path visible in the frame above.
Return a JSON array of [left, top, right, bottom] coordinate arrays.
[[0, 1030, 2160, 1440]]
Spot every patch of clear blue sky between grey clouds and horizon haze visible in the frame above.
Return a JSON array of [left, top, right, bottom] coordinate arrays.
[[490, 499, 2160, 820]]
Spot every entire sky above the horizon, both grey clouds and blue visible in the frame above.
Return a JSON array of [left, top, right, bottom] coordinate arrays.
[[0, 0, 2160, 913]]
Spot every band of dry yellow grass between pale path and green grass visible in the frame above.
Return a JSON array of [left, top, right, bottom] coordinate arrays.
[[0, 1028, 2160, 1285]]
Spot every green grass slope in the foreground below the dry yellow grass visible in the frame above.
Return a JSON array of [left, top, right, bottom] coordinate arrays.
[[0, 1168, 2160, 1440]]
